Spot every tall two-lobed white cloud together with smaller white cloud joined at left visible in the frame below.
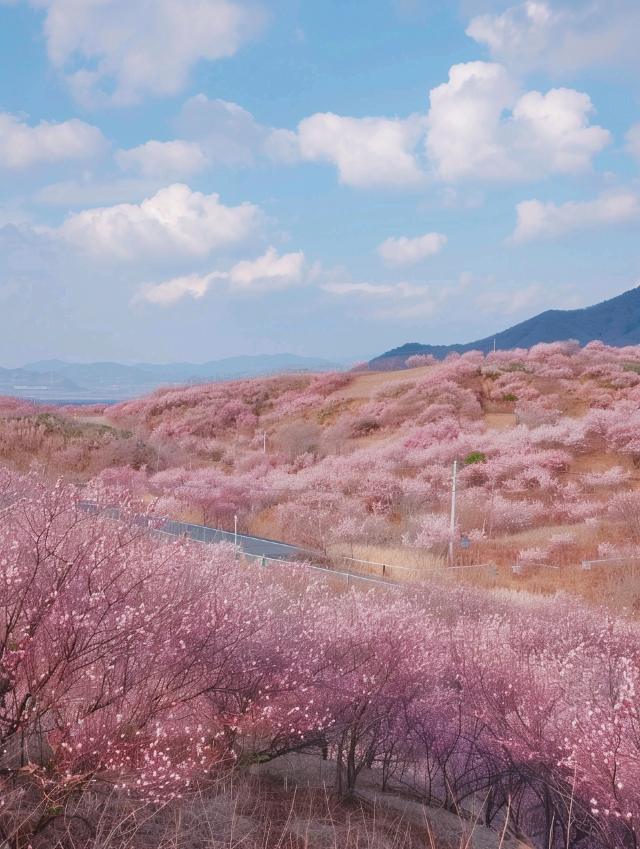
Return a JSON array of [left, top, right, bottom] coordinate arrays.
[[276, 68, 612, 189]]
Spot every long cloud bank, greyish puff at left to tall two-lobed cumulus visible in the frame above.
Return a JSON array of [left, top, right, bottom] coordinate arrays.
[[129, 62, 611, 191]]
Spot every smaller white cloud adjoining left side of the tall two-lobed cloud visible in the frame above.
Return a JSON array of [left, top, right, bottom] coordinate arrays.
[[292, 112, 424, 188]]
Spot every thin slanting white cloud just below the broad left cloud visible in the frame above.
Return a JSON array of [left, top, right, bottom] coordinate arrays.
[[133, 247, 308, 306]]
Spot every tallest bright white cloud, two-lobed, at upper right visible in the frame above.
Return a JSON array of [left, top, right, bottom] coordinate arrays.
[[426, 62, 611, 182]]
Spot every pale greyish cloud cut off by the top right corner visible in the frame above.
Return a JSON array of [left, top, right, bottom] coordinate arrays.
[[467, 0, 640, 75]]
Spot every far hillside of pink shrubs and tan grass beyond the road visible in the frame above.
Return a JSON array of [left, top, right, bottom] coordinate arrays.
[[0, 343, 640, 610]]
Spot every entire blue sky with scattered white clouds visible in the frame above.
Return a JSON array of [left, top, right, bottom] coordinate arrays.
[[0, 0, 640, 367]]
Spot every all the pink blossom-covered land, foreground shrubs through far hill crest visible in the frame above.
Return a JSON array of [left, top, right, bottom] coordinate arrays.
[[0, 342, 640, 849]]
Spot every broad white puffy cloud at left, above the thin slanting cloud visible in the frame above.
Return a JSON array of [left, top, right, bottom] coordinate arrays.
[[56, 183, 262, 260]]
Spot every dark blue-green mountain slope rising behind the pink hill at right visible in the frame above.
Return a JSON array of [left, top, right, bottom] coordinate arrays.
[[369, 288, 640, 371]]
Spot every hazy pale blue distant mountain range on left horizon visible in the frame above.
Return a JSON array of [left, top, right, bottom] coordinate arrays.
[[0, 354, 342, 402]]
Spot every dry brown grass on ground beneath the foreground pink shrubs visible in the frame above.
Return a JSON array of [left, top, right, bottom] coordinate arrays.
[[0, 771, 440, 849]]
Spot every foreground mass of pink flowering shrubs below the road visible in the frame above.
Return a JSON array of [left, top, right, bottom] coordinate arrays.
[[0, 471, 640, 849]]
